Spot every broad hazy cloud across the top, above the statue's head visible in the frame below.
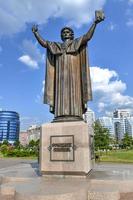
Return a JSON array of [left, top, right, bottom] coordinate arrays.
[[0, 0, 106, 35]]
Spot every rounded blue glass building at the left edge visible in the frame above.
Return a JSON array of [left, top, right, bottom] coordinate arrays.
[[0, 111, 20, 143]]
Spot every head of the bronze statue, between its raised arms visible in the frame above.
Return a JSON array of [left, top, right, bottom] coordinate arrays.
[[61, 27, 74, 41]]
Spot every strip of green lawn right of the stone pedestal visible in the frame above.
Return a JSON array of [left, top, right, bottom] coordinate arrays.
[[96, 150, 133, 163]]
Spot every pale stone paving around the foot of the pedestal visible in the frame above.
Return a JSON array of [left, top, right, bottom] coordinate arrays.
[[0, 158, 133, 200]]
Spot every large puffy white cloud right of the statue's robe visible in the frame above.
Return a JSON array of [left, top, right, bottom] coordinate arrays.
[[91, 67, 133, 112]]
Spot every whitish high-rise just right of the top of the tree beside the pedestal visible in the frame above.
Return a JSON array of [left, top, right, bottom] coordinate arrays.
[[98, 117, 115, 137]]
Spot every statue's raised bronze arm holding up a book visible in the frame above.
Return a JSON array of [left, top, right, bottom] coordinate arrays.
[[82, 11, 105, 44]]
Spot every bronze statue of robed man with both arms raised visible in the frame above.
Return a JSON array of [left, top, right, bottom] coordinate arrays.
[[32, 11, 104, 122]]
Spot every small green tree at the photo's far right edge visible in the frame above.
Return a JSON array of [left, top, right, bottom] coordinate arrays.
[[122, 133, 133, 149]]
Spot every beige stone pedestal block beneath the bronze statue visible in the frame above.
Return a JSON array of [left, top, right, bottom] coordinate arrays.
[[40, 121, 94, 176]]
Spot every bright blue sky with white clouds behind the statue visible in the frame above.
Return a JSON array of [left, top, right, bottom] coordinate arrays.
[[0, 0, 133, 129]]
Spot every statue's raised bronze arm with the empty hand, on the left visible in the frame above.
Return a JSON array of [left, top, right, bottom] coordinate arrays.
[[32, 25, 47, 48]]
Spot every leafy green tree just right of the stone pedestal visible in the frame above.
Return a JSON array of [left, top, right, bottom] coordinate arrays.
[[94, 121, 110, 151]]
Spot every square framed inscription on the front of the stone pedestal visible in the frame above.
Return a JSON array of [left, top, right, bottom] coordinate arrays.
[[49, 135, 74, 161]]
